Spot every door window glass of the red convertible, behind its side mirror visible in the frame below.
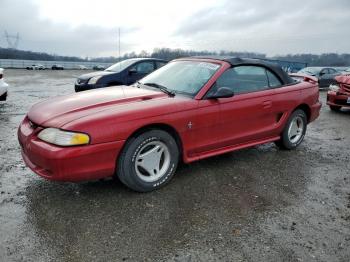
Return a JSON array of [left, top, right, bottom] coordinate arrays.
[[216, 66, 270, 94]]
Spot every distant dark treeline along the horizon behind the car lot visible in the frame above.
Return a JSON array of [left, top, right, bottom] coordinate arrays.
[[0, 48, 350, 66]]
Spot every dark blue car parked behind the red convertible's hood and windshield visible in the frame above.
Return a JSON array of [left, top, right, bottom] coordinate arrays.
[[75, 58, 168, 92]]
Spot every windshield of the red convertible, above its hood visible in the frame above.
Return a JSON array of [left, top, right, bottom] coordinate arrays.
[[140, 61, 220, 96]]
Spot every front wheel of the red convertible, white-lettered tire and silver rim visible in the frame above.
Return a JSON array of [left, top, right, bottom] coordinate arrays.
[[117, 129, 179, 192]]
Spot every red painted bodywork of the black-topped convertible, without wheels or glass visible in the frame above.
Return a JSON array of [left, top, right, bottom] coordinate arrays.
[[18, 59, 321, 181]]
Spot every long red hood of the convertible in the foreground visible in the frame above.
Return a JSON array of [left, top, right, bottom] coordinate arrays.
[[28, 86, 169, 128]]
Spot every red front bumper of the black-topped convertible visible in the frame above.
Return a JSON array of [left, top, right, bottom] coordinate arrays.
[[18, 117, 124, 182]]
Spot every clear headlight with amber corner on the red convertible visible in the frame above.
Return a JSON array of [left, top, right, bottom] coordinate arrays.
[[38, 127, 90, 146]]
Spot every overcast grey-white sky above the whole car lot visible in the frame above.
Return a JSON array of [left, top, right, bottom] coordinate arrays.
[[0, 0, 350, 57]]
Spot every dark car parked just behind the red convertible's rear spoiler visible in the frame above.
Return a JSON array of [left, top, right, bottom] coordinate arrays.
[[298, 67, 341, 88]]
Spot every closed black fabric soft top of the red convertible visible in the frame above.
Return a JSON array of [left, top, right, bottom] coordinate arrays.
[[191, 56, 295, 85]]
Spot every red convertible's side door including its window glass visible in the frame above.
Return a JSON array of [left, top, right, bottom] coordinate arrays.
[[209, 66, 281, 147]]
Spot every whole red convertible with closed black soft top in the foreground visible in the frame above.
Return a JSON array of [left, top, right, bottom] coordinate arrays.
[[18, 57, 321, 192]]
